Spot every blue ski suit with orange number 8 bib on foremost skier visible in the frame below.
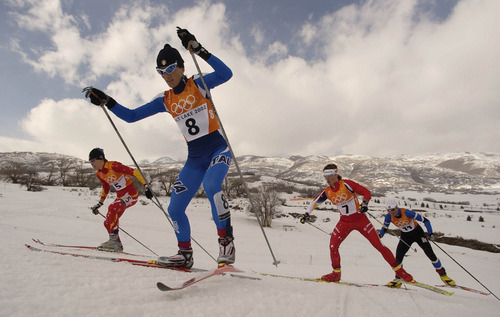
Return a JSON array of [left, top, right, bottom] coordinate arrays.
[[111, 54, 233, 249]]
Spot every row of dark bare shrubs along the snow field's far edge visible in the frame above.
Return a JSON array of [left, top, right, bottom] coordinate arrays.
[[0, 158, 317, 227]]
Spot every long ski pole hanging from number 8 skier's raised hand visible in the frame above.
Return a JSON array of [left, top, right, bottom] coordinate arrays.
[[189, 46, 280, 267]]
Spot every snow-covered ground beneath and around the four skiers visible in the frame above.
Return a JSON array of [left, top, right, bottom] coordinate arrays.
[[0, 183, 500, 317]]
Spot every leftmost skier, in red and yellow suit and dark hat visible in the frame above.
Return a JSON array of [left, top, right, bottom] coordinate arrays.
[[89, 148, 152, 251]]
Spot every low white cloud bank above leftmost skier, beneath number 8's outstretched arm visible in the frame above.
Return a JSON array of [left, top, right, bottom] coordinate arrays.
[[16, 99, 185, 162]]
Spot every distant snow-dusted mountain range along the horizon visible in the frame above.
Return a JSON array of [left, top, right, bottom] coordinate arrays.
[[0, 152, 500, 194]]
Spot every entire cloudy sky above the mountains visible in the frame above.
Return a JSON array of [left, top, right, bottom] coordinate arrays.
[[0, 0, 500, 162]]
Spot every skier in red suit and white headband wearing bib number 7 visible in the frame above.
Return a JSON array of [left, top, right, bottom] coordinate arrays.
[[300, 164, 413, 282]]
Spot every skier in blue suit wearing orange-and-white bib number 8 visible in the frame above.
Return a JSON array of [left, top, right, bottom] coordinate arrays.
[[85, 28, 235, 268]]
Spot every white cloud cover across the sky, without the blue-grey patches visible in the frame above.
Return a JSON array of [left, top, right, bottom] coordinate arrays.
[[3, 0, 500, 159]]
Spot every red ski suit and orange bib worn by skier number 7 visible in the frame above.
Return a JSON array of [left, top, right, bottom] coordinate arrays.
[[307, 179, 398, 270]]
